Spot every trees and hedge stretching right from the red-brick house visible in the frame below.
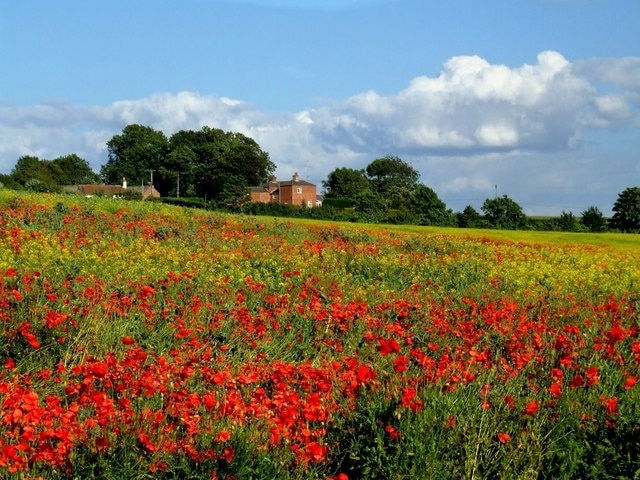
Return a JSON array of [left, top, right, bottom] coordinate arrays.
[[323, 156, 640, 232]]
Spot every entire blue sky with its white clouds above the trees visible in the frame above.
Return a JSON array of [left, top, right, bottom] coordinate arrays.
[[0, 0, 640, 215]]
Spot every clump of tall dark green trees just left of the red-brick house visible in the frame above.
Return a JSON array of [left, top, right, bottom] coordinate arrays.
[[101, 125, 275, 204]]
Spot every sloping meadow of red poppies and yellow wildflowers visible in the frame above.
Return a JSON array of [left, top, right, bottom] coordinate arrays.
[[0, 191, 640, 480]]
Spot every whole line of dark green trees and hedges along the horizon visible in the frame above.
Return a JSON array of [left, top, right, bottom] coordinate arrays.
[[0, 124, 640, 232]]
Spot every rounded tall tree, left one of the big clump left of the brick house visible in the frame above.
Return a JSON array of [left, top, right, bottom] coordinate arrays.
[[100, 124, 169, 185]]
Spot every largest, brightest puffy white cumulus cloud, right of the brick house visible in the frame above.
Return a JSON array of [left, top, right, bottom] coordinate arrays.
[[306, 51, 632, 154]]
